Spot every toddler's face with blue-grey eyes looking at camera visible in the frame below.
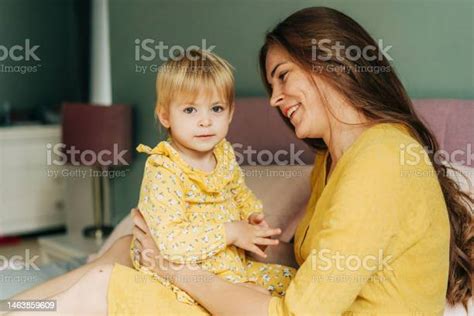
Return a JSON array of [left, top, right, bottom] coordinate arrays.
[[159, 89, 233, 152]]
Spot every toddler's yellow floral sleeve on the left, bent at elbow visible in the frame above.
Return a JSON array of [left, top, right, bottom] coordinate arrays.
[[139, 156, 226, 263]]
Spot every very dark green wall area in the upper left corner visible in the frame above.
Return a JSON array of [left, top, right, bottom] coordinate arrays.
[[0, 0, 88, 111]]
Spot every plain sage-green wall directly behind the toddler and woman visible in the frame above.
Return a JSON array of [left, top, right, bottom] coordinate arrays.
[[109, 0, 474, 223]]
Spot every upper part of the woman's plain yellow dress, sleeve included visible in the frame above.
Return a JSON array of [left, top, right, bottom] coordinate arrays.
[[269, 123, 450, 315]]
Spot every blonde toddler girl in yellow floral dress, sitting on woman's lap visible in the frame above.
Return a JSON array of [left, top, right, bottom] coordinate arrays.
[[131, 50, 295, 304]]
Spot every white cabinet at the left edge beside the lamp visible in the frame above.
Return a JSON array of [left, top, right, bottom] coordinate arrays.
[[0, 125, 65, 236]]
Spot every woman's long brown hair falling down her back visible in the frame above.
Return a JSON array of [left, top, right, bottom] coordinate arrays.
[[259, 7, 474, 307]]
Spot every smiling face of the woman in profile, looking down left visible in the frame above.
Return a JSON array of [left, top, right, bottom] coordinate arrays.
[[265, 46, 329, 139]]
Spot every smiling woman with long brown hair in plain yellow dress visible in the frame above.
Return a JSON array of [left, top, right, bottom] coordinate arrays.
[[10, 7, 474, 315]]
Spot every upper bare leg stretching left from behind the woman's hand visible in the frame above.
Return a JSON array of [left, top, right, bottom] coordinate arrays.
[[12, 235, 132, 300]]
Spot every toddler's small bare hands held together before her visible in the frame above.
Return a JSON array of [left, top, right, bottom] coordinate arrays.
[[224, 221, 281, 258]]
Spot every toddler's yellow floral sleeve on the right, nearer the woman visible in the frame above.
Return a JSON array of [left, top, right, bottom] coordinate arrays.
[[231, 163, 263, 220]]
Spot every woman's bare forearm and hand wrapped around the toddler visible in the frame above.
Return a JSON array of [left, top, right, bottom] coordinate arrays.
[[132, 209, 271, 315]]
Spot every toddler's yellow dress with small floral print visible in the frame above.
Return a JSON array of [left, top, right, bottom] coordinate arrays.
[[131, 139, 295, 304]]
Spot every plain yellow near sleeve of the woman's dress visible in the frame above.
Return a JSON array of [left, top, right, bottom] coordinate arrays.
[[269, 145, 414, 315]]
